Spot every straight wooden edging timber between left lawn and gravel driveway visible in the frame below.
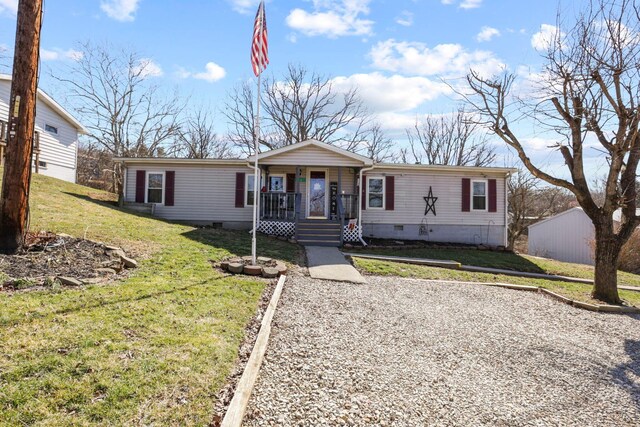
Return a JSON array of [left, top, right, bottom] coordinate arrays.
[[221, 275, 287, 427]]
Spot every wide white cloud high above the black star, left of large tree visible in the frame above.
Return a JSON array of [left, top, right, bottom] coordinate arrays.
[[369, 39, 505, 76]]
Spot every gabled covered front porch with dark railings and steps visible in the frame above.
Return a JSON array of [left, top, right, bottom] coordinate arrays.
[[250, 141, 372, 246]]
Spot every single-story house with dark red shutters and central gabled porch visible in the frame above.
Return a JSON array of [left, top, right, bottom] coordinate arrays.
[[116, 140, 513, 246]]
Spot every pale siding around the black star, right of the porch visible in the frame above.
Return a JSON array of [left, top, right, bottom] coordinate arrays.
[[362, 168, 505, 227]]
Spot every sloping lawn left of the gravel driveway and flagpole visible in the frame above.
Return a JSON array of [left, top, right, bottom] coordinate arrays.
[[0, 170, 300, 426]]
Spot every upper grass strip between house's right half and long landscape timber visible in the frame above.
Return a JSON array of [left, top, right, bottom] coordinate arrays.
[[353, 247, 640, 286]]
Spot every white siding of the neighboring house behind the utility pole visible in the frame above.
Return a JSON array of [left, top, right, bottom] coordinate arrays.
[[0, 80, 78, 182]]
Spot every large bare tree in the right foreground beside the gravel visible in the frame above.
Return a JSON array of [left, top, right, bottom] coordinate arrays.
[[467, 0, 640, 303]]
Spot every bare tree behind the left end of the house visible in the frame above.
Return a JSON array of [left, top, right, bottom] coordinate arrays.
[[54, 43, 183, 194]]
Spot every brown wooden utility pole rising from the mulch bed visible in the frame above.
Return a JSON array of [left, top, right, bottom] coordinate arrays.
[[0, 0, 42, 253]]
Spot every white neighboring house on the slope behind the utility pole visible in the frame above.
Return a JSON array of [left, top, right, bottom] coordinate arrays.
[[0, 74, 86, 182]]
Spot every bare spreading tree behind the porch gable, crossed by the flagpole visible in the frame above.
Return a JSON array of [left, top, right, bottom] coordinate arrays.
[[223, 65, 369, 154]]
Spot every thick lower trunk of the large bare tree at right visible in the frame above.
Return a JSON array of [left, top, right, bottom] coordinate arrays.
[[593, 224, 622, 304]]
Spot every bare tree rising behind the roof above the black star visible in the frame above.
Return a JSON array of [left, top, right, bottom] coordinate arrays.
[[403, 108, 496, 166]]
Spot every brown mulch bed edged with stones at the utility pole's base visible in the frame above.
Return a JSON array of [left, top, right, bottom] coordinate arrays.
[[0, 232, 136, 290]]
